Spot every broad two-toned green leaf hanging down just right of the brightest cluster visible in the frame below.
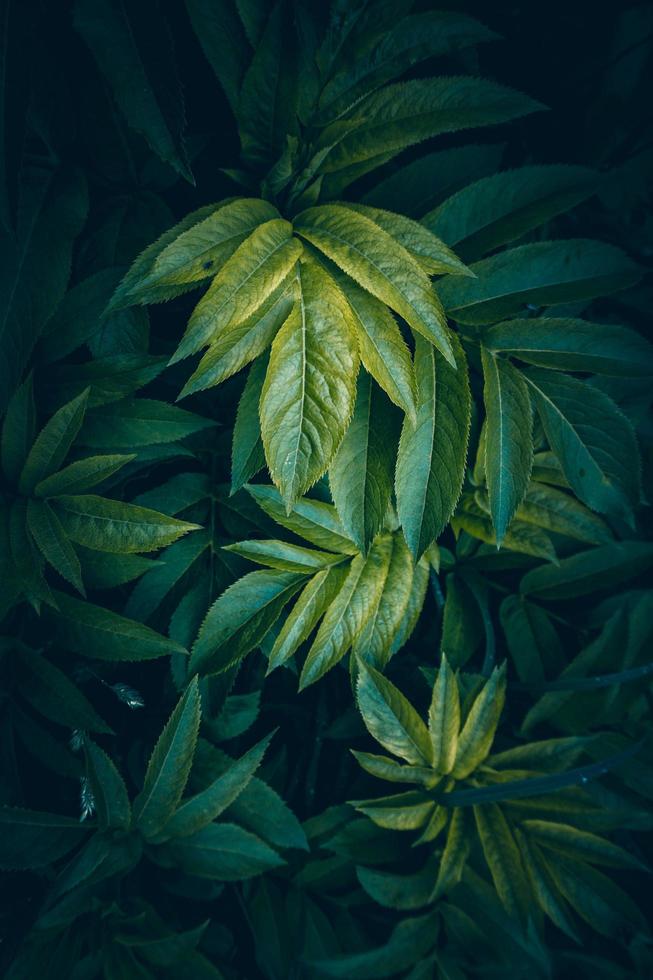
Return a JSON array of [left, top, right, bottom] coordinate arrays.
[[395, 337, 471, 559]]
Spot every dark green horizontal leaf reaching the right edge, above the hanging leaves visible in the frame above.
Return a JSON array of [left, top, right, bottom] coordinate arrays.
[[483, 316, 653, 378]]
